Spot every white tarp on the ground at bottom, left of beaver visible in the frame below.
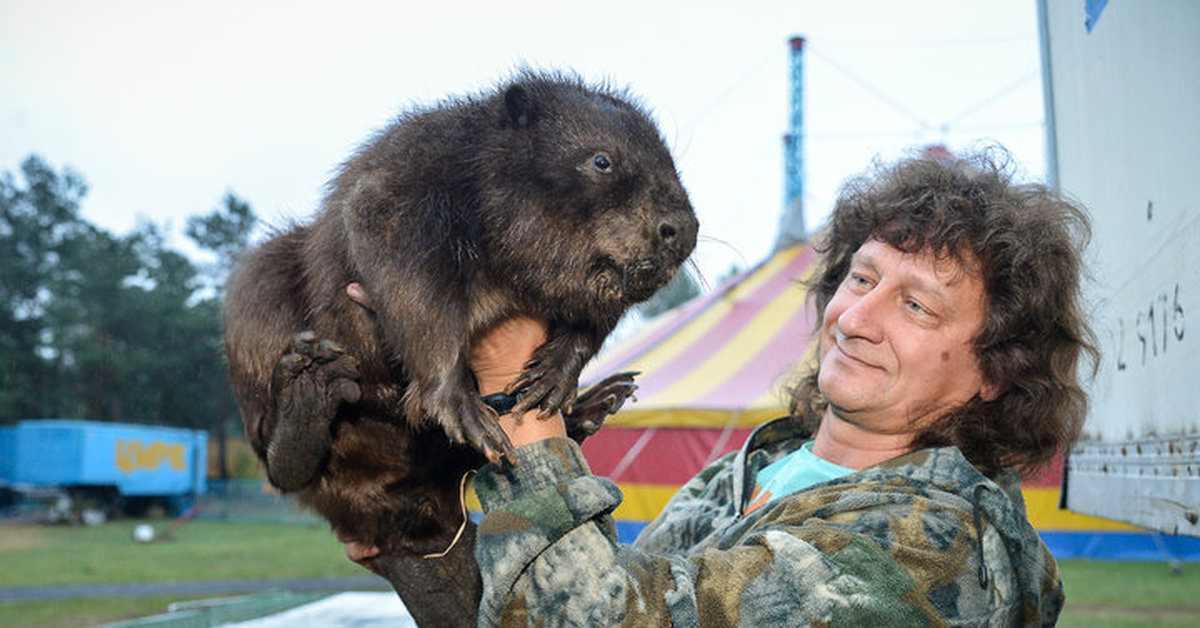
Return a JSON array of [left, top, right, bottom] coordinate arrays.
[[220, 591, 416, 628]]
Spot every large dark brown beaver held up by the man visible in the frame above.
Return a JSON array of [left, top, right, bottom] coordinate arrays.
[[223, 70, 697, 626]]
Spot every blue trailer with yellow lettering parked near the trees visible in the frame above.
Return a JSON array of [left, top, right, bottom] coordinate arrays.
[[0, 419, 208, 522]]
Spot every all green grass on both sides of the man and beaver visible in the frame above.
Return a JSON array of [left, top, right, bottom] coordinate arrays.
[[0, 520, 1200, 628]]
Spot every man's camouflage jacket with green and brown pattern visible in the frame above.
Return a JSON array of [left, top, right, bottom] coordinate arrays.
[[475, 419, 1063, 628]]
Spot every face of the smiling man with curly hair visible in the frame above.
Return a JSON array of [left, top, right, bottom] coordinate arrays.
[[817, 240, 995, 433]]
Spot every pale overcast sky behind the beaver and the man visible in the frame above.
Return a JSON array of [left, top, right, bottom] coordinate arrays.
[[0, 0, 1051, 282]]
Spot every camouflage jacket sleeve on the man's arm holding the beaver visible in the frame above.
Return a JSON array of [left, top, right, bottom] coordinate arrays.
[[475, 438, 937, 628]]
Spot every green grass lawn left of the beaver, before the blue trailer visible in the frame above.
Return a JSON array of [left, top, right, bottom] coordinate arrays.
[[0, 520, 367, 628]]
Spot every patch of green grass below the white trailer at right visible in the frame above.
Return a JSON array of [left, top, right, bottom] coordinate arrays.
[[1058, 561, 1200, 628]]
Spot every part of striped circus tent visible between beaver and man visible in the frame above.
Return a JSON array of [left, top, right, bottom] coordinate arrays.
[[581, 244, 816, 540]]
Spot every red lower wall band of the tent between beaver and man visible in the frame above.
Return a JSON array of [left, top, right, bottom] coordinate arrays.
[[583, 427, 752, 485]]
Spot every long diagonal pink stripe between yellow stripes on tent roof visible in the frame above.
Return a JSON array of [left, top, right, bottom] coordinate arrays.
[[638, 250, 811, 401]]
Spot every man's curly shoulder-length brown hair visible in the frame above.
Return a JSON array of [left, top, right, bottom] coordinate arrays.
[[791, 149, 1099, 473]]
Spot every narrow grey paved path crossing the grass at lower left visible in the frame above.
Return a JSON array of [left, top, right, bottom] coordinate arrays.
[[0, 575, 395, 603]]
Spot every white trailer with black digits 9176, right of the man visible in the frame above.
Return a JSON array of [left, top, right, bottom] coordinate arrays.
[[1038, 0, 1200, 536]]
